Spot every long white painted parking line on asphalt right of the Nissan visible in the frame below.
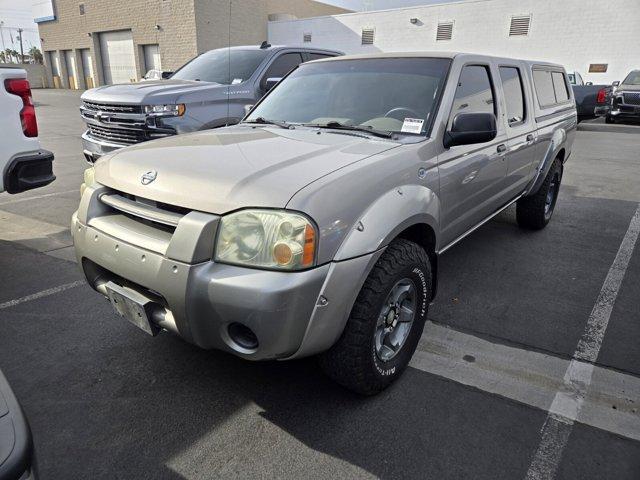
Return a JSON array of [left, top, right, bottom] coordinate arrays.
[[526, 205, 640, 480]]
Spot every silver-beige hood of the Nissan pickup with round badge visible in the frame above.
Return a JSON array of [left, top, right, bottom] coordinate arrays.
[[95, 125, 399, 214]]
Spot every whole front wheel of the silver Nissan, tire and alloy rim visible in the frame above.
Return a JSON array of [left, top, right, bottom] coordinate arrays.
[[319, 239, 432, 395]]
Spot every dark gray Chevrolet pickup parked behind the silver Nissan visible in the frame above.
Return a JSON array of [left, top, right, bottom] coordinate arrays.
[[80, 42, 341, 162]]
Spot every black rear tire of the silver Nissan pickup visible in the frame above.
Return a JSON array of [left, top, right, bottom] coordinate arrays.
[[516, 159, 562, 230]]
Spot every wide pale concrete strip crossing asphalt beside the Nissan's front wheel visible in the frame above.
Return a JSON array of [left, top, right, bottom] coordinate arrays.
[[411, 322, 640, 442]]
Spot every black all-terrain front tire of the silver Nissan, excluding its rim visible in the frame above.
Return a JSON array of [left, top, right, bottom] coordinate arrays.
[[319, 239, 432, 395]]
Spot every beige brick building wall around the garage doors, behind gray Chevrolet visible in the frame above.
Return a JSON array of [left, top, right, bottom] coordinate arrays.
[[38, 0, 346, 89]]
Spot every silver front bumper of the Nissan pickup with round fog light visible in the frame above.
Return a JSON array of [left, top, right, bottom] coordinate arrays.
[[71, 184, 381, 360]]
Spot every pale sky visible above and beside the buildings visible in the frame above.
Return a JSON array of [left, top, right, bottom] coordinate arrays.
[[0, 0, 451, 52]]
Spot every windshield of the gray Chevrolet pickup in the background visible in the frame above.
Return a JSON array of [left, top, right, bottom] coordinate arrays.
[[171, 48, 268, 85]]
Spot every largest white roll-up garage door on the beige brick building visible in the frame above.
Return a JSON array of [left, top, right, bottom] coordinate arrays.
[[100, 30, 138, 84]]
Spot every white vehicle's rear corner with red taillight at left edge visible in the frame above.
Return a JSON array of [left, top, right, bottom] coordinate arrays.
[[0, 67, 56, 193]]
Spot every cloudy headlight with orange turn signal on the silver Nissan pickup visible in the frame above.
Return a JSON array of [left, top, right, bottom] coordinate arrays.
[[214, 210, 317, 270]]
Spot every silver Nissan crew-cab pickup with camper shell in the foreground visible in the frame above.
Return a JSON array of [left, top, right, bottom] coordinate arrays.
[[72, 53, 577, 394]]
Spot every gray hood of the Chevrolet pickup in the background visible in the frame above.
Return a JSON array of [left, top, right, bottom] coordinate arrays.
[[80, 79, 227, 105]]
